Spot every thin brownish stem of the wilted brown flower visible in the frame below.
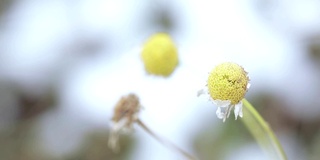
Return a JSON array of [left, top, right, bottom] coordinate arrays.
[[136, 119, 196, 160]]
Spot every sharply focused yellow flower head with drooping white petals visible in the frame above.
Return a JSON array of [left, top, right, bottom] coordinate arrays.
[[198, 62, 250, 122]]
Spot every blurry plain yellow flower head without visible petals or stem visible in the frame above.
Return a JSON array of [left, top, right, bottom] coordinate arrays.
[[141, 33, 178, 77]]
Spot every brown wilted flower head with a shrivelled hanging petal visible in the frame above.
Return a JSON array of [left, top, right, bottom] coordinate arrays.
[[109, 94, 141, 151]]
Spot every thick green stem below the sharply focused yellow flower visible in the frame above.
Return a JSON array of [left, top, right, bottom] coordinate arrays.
[[242, 99, 287, 160]]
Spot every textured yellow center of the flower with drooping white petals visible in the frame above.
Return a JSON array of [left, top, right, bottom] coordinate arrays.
[[208, 62, 249, 104]]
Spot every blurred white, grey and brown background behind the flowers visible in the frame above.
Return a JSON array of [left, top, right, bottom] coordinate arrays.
[[0, 0, 320, 160]]
